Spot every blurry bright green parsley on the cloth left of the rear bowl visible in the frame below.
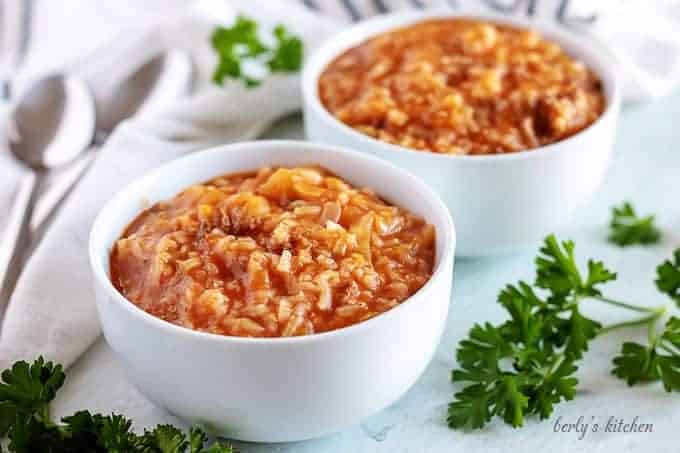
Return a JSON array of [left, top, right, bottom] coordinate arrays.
[[210, 16, 304, 88]]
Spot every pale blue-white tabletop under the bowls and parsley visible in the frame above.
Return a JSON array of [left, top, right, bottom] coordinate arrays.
[[54, 93, 680, 453]]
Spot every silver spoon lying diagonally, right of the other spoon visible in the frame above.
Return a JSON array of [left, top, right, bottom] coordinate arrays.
[[30, 50, 195, 235]]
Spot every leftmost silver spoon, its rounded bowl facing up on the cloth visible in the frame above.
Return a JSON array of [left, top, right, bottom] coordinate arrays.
[[0, 75, 95, 291]]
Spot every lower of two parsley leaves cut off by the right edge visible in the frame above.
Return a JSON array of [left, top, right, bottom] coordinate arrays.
[[612, 317, 680, 392]]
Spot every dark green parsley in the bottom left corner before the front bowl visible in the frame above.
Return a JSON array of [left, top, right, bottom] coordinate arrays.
[[0, 357, 236, 453]]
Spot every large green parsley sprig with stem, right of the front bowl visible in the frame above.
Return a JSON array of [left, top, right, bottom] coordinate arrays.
[[448, 235, 680, 429]]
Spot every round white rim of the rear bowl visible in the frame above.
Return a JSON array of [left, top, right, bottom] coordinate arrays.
[[301, 8, 621, 164]]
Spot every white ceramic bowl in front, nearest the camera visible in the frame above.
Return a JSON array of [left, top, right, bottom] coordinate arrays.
[[89, 141, 455, 442]]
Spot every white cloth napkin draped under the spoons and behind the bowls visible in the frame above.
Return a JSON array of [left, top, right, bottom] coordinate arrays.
[[0, 0, 680, 369]]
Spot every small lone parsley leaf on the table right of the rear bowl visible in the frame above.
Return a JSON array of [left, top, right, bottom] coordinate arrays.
[[608, 201, 661, 247]]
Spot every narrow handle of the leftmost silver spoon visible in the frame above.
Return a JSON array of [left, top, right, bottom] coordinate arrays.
[[0, 171, 38, 305]]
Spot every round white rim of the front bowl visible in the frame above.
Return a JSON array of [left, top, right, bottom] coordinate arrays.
[[88, 140, 456, 347]]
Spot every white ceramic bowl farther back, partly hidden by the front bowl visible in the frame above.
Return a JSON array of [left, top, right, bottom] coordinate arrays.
[[302, 11, 620, 256]]
